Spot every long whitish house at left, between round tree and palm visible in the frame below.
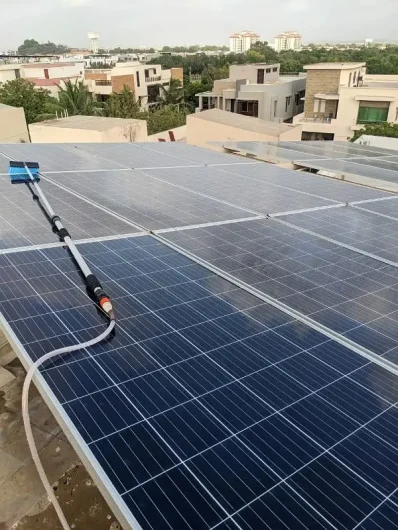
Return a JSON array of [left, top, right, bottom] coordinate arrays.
[[21, 62, 84, 96]]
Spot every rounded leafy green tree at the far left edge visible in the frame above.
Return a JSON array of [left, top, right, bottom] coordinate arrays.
[[0, 79, 52, 123]]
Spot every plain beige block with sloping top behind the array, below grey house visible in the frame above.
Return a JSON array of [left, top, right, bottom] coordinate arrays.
[[187, 109, 301, 150]]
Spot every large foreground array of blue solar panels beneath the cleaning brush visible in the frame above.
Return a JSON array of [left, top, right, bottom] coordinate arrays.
[[0, 144, 398, 530]]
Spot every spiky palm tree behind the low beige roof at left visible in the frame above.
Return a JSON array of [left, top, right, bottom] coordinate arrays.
[[40, 79, 103, 119]]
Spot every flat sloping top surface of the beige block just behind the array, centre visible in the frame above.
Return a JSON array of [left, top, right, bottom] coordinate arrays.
[[192, 109, 293, 138]]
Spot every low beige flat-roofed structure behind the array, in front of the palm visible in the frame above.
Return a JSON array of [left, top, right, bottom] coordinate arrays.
[[29, 116, 148, 143]]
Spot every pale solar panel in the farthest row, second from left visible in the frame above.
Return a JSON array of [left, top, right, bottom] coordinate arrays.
[[72, 142, 255, 168]]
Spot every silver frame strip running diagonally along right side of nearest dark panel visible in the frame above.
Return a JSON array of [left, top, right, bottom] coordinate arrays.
[[151, 230, 398, 376]]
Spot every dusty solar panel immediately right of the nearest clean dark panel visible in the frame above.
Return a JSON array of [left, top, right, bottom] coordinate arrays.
[[162, 217, 398, 355]]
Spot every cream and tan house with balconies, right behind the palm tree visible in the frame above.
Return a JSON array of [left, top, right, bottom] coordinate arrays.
[[85, 62, 183, 109]]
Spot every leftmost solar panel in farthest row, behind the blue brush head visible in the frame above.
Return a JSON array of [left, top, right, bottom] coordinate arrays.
[[0, 144, 123, 173]]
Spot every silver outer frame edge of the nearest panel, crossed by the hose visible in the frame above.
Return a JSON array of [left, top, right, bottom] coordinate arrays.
[[0, 312, 143, 530]]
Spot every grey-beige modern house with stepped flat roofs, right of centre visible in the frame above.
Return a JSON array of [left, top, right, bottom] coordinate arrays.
[[196, 63, 306, 122]]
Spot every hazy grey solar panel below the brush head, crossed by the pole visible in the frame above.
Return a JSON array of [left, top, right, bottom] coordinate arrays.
[[0, 176, 139, 250]]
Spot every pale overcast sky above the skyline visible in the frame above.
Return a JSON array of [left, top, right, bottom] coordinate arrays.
[[0, 0, 398, 49]]
